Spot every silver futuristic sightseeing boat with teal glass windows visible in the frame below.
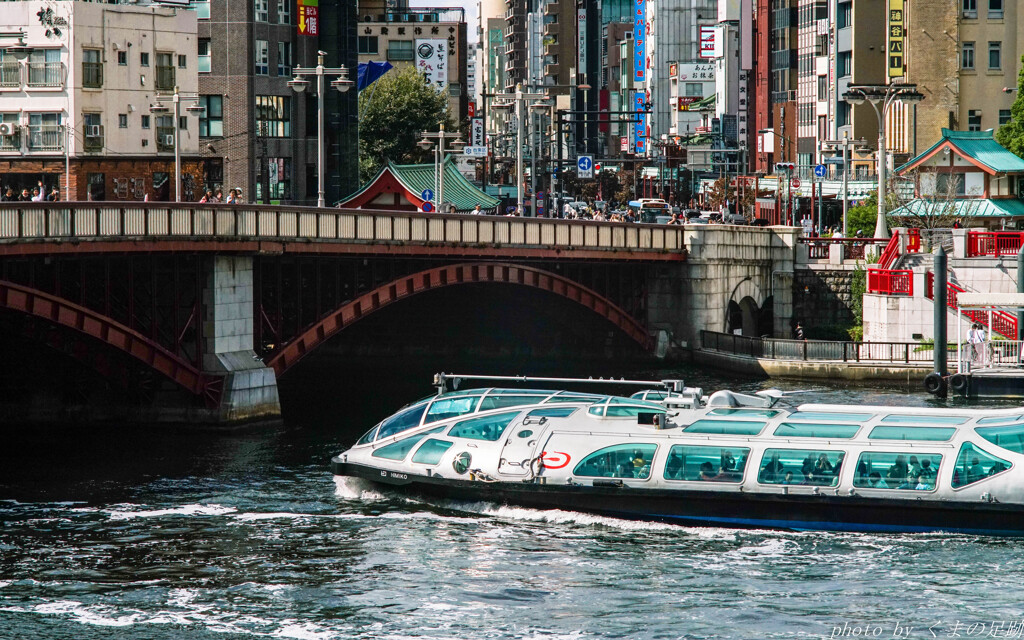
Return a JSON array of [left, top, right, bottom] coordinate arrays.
[[332, 374, 1024, 536]]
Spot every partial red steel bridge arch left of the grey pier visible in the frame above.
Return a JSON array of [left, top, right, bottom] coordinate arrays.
[[0, 281, 221, 401]]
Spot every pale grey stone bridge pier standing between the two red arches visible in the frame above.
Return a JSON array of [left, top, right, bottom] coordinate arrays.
[[203, 256, 281, 424]]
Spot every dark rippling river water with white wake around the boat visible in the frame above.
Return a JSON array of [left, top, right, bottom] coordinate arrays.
[[0, 370, 1024, 640]]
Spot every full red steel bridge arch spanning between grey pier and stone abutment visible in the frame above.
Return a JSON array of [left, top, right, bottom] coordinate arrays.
[[267, 262, 652, 377]]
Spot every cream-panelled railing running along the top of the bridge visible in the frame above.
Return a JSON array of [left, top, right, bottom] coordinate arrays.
[[0, 203, 685, 252]]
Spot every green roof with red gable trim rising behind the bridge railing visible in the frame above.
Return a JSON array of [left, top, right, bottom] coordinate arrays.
[[338, 159, 501, 211]]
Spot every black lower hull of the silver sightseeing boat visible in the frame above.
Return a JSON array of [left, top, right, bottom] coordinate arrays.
[[332, 461, 1024, 537]]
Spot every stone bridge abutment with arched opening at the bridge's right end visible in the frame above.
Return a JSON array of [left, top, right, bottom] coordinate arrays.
[[647, 224, 798, 354]]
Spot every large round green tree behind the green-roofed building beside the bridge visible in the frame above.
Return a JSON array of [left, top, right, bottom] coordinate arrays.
[[359, 67, 455, 182]]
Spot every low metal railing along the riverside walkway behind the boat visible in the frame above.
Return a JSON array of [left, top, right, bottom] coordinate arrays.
[[700, 331, 956, 364]]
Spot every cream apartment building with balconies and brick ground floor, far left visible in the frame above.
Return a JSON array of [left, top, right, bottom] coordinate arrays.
[[0, 1, 206, 201]]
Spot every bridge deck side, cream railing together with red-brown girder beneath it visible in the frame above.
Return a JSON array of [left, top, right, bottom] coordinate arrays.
[[0, 203, 685, 261]]
